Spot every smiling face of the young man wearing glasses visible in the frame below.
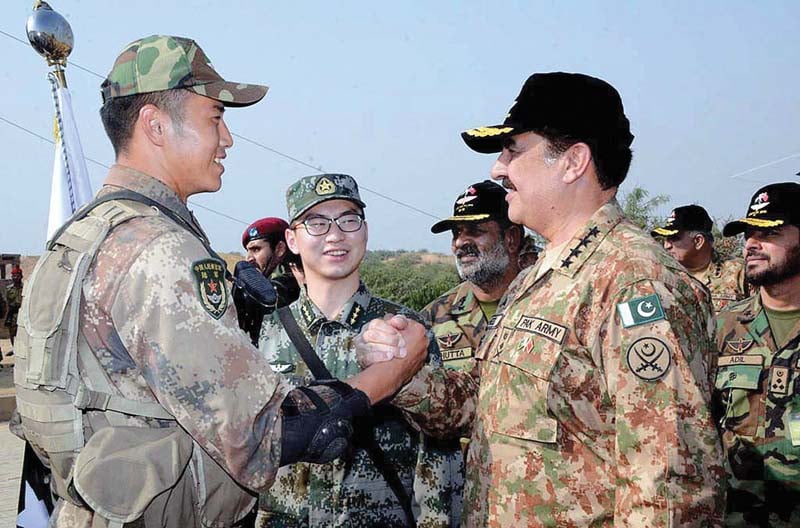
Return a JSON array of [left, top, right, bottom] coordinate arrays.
[[286, 200, 367, 282]]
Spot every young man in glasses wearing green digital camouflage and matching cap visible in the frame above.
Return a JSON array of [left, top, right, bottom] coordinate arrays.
[[257, 174, 451, 527]]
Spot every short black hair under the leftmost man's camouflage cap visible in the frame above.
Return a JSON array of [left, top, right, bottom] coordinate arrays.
[[100, 89, 187, 157]]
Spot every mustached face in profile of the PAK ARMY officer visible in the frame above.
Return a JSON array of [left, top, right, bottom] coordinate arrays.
[[491, 132, 564, 233]]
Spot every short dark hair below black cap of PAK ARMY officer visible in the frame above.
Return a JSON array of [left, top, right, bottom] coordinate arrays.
[[533, 127, 633, 190]]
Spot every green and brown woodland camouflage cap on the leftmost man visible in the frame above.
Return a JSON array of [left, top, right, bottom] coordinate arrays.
[[100, 35, 267, 106]]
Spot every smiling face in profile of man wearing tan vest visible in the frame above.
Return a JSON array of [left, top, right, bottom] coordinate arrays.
[[165, 92, 233, 200]]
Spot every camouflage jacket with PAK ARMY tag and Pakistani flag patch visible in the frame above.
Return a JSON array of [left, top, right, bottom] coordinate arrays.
[[394, 200, 724, 527]]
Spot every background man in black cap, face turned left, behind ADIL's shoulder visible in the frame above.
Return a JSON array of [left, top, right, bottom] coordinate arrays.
[[650, 205, 750, 312]]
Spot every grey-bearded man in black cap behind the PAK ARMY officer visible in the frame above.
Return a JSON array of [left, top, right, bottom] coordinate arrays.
[[417, 180, 524, 526]]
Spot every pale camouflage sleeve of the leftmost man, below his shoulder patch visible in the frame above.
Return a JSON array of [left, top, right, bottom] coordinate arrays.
[[111, 231, 290, 490]]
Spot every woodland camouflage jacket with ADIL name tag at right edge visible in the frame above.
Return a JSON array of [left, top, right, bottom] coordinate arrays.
[[713, 294, 800, 527]]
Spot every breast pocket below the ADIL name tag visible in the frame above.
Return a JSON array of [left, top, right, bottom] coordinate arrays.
[[714, 355, 764, 436]]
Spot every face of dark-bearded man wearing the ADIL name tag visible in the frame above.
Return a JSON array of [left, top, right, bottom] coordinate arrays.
[[744, 225, 800, 286]]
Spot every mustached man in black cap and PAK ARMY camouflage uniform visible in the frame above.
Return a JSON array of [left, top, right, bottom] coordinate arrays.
[[356, 73, 724, 527]]
